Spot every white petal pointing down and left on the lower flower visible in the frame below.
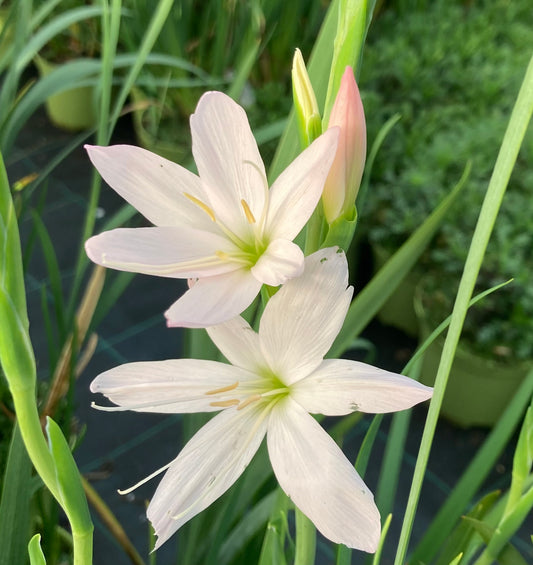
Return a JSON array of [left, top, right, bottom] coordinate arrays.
[[147, 407, 266, 549]]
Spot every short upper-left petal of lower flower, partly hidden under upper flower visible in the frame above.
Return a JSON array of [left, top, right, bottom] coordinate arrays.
[[207, 316, 265, 371]]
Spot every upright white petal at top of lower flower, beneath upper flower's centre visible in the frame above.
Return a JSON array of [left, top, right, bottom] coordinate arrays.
[[259, 248, 352, 385]]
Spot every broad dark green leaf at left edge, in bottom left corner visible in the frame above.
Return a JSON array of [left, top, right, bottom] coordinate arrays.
[[0, 424, 32, 565]]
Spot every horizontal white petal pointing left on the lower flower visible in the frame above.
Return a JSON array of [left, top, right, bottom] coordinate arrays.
[[91, 359, 256, 414]]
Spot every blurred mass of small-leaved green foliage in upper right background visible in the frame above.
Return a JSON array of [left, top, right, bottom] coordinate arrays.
[[362, 0, 533, 360]]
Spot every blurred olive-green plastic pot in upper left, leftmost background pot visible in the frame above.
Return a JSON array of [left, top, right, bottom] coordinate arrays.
[[34, 55, 97, 131]]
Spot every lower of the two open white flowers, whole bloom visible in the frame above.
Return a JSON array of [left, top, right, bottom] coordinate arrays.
[[91, 248, 432, 552]]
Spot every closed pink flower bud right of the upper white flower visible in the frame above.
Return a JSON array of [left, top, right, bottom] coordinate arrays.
[[322, 67, 366, 224]]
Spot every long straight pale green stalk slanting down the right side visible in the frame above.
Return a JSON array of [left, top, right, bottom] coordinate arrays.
[[394, 53, 533, 565]]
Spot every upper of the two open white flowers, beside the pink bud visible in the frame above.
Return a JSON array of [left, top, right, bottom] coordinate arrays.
[[86, 92, 338, 327]]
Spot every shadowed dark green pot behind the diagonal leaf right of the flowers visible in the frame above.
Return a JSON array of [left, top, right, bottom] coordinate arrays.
[[372, 244, 420, 337]]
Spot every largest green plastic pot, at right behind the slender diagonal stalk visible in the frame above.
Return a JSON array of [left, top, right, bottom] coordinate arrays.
[[414, 283, 531, 428]]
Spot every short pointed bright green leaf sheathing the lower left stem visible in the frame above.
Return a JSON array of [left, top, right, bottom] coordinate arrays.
[[46, 418, 93, 532]]
